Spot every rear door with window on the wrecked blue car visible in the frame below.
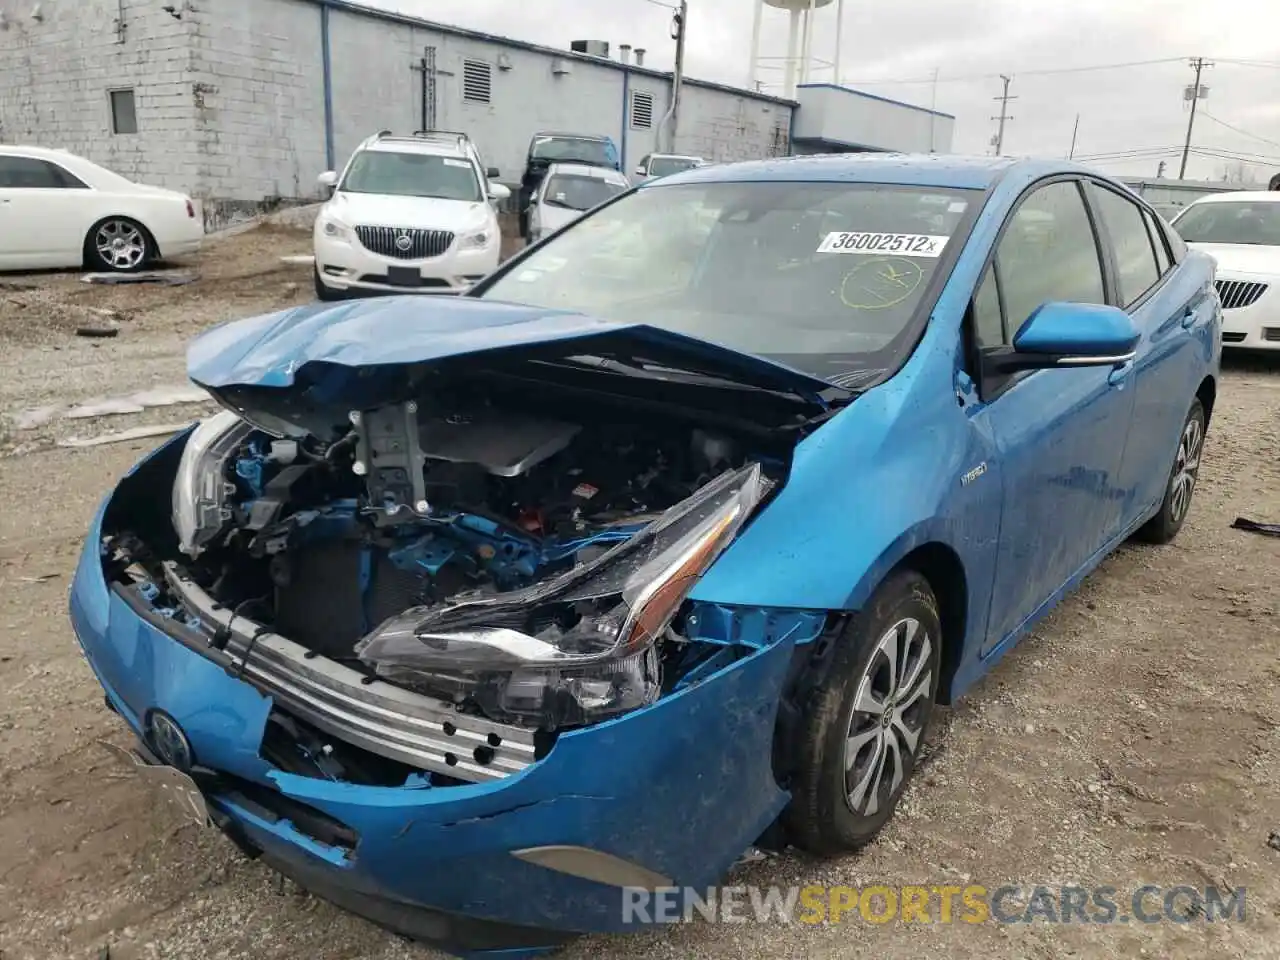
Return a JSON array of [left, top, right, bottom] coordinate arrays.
[[1089, 183, 1213, 534]]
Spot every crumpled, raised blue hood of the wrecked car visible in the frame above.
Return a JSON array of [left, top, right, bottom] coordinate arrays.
[[187, 297, 833, 419]]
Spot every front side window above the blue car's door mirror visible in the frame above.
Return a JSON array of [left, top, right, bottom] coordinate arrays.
[[996, 180, 1105, 337]]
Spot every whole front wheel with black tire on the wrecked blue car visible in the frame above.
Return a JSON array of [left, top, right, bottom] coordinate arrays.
[[783, 570, 942, 855]]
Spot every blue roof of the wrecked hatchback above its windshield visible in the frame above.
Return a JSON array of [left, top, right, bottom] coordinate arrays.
[[646, 154, 1091, 189]]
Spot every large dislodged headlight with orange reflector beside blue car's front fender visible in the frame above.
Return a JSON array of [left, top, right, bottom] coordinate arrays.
[[356, 463, 767, 730]]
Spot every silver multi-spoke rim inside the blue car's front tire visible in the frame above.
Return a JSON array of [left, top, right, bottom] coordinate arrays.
[[845, 617, 933, 817]]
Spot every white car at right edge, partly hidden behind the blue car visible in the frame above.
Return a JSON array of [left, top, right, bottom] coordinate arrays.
[[1172, 192, 1280, 349]]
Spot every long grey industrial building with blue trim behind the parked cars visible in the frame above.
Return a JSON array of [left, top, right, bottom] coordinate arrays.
[[0, 0, 954, 225]]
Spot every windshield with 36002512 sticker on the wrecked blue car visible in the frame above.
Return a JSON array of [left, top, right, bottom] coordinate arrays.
[[481, 182, 980, 378]]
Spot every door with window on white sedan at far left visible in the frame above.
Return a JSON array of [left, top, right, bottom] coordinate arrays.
[[0, 154, 91, 270]]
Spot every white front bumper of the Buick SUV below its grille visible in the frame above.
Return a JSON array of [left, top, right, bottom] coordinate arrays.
[[315, 227, 502, 293]]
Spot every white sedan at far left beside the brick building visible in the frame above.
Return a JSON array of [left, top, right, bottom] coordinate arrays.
[[0, 145, 205, 273]]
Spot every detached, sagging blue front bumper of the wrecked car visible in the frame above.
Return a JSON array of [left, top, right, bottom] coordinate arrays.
[[70, 442, 799, 954]]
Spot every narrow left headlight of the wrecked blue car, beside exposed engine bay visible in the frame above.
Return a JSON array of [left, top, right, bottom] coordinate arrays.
[[173, 411, 253, 557]]
